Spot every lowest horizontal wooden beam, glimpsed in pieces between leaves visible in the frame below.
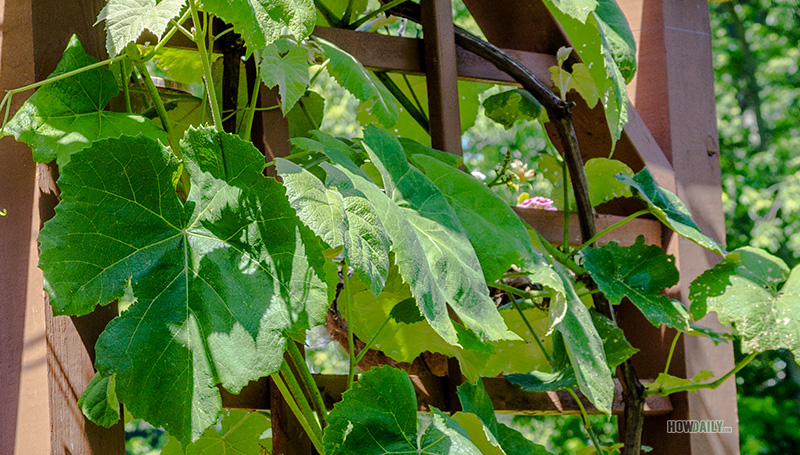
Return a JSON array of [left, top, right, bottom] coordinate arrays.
[[222, 374, 672, 416]]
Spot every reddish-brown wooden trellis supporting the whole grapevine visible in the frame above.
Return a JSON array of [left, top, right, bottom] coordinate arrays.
[[0, 0, 738, 455]]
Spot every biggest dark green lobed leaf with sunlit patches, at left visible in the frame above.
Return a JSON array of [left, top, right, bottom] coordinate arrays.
[[39, 128, 335, 442]]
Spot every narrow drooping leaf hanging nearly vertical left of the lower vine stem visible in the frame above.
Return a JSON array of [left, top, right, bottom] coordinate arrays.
[[555, 268, 614, 414]]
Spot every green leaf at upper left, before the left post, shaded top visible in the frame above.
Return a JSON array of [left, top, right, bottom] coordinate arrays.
[[2, 35, 167, 165]]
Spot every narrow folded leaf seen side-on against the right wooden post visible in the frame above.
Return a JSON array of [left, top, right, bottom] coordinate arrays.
[[617, 168, 726, 256]]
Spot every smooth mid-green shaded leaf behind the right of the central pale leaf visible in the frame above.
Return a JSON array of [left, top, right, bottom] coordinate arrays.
[[412, 155, 550, 282]]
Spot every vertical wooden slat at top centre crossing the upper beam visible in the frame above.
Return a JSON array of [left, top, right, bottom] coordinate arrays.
[[421, 0, 461, 155]]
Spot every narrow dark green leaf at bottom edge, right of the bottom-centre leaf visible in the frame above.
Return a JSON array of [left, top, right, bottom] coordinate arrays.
[[457, 379, 550, 455]]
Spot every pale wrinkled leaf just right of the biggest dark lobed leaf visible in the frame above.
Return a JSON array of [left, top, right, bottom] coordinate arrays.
[[276, 158, 389, 295]]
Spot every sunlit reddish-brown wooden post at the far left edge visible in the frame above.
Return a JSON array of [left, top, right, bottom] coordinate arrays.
[[0, 0, 125, 455]]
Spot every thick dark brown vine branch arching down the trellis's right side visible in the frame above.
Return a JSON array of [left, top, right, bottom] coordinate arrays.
[[381, 0, 645, 455]]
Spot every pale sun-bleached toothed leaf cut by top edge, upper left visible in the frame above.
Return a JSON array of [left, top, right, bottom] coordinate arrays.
[[95, 0, 186, 57]]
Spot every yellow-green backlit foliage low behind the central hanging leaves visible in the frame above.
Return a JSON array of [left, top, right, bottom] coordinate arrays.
[[352, 265, 549, 381]]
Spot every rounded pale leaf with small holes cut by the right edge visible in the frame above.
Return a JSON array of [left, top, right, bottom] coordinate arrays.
[[695, 248, 800, 356]]
